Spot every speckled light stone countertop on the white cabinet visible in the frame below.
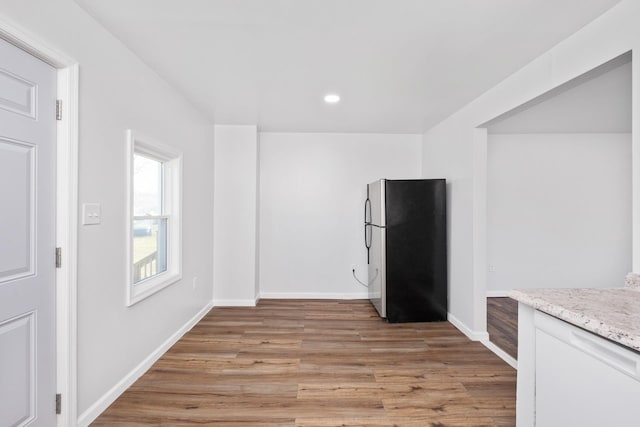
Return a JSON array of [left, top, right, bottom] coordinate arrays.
[[509, 286, 640, 351]]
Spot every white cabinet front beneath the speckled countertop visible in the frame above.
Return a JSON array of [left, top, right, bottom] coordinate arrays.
[[518, 311, 640, 427]]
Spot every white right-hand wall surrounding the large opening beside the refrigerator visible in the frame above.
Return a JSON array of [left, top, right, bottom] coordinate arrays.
[[422, 0, 640, 340]]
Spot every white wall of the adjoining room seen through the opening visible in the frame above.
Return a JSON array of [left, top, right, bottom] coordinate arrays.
[[487, 133, 631, 295]]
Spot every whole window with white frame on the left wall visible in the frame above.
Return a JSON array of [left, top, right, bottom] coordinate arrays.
[[127, 130, 182, 305]]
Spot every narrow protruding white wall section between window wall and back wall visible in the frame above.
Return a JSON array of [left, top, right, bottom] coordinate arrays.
[[213, 125, 258, 306]]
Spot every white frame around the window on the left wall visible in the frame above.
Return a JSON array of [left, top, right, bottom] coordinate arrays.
[[126, 129, 182, 306]]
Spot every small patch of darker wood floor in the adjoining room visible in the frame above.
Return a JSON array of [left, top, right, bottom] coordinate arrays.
[[487, 297, 518, 359]]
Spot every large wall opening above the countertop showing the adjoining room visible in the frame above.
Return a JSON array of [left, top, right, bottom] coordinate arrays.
[[482, 52, 632, 362]]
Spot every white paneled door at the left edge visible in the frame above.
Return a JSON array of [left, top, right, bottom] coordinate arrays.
[[0, 36, 56, 426]]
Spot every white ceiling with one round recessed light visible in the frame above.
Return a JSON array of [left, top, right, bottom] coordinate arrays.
[[76, 0, 619, 133]]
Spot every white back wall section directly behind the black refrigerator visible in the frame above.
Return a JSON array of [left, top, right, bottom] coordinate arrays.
[[259, 133, 421, 298]]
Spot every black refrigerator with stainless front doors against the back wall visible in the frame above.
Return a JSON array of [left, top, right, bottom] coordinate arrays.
[[364, 179, 447, 322]]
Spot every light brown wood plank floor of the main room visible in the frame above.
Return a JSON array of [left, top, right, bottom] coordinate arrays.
[[93, 300, 516, 427]]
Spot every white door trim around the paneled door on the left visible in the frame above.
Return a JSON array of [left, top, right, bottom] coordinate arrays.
[[0, 18, 79, 426]]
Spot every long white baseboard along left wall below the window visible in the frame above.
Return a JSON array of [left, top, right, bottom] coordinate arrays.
[[78, 303, 213, 427]]
